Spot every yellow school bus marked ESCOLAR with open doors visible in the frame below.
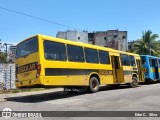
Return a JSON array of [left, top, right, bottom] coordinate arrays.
[[16, 35, 144, 92]]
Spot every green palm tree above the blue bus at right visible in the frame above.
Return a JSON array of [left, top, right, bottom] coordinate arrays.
[[133, 30, 160, 56]]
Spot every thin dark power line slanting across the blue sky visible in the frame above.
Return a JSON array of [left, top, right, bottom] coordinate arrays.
[[0, 6, 81, 30]]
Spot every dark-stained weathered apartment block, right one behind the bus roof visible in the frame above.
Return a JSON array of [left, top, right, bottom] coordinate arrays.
[[88, 30, 128, 51]]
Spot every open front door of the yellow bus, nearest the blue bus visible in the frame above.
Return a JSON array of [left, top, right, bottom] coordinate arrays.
[[136, 59, 145, 82]]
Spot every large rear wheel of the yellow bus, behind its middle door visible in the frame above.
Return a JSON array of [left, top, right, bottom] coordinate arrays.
[[89, 77, 99, 93]]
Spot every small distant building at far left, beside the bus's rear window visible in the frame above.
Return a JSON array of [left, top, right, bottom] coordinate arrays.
[[7, 45, 16, 62]]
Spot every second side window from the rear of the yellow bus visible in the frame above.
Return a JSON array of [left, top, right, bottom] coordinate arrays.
[[67, 45, 84, 62]]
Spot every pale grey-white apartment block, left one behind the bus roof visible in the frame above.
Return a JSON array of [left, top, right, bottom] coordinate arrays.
[[56, 30, 88, 43]]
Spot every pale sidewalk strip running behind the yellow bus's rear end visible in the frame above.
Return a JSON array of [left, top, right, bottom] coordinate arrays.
[[0, 88, 63, 102]]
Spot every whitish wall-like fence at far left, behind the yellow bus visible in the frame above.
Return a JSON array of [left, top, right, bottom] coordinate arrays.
[[0, 63, 16, 90]]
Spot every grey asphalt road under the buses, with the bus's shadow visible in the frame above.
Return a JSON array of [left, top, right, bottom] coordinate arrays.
[[0, 83, 160, 120]]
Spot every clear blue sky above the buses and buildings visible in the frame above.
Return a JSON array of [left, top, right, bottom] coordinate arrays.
[[0, 0, 160, 44]]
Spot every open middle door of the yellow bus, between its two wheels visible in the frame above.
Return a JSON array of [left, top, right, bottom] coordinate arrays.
[[111, 56, 124, 83]]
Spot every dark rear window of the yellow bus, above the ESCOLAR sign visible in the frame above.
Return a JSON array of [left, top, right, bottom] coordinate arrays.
[[16, 37, 38, 58]]
